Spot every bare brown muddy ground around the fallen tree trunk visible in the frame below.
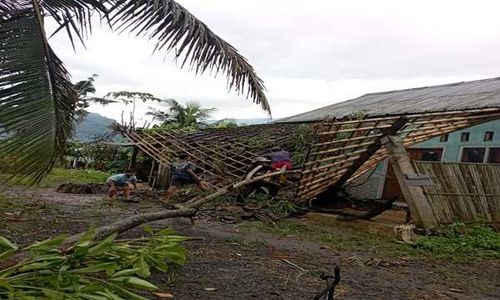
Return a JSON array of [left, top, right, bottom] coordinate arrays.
[[0, 188, 500, 299]]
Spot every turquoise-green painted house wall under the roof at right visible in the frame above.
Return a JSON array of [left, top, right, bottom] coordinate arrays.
[[412, 120, 500, 162]]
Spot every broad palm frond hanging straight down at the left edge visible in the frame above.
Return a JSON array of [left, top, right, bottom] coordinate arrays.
[[0, 6, 77, 181]]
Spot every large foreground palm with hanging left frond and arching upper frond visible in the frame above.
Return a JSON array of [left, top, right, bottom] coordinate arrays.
[[0, 0, 270, 181]]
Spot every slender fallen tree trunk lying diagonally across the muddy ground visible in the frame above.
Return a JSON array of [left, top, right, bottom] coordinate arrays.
[[0, 170, 297, 270]]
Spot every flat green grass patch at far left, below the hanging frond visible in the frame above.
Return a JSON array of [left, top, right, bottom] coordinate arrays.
[[4, 168, 111, 187]]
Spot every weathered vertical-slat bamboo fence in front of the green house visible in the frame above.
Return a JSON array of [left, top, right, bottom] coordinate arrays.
[[414, 162, 500, 224]]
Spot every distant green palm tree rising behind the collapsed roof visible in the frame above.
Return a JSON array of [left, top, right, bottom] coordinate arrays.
[[147, 99, 215, 128]]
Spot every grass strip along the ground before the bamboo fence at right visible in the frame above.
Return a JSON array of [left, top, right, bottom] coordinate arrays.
[[240, 219, 500, 261]]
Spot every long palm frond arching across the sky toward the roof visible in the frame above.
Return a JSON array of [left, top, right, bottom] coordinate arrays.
[[109, 0, 271, 114]]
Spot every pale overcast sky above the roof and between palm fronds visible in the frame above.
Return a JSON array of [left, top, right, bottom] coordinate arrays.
[[51, 0, 500, 119]]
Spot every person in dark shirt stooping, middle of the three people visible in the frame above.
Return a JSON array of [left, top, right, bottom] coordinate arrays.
[[164, 153, 209, 202]]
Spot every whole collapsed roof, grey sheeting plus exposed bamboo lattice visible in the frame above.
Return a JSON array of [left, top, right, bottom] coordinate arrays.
[[123, 78, 500, 203]]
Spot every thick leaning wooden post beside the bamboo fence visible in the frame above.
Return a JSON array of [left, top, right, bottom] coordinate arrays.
[[382, 136, 437, 227]]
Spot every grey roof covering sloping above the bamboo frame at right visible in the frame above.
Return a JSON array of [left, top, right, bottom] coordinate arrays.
[[276, 77, 500, 123]]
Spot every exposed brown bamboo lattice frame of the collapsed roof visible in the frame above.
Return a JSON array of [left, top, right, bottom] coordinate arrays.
[[122, 107, 500, 203]]
